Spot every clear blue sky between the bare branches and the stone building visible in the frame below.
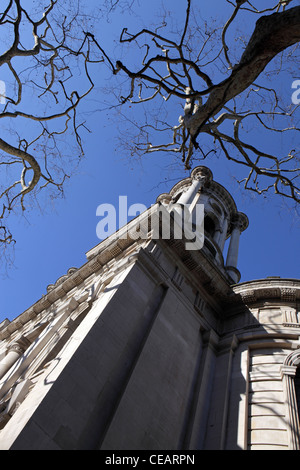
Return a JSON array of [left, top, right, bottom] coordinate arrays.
[[0, 0, 300, 321]]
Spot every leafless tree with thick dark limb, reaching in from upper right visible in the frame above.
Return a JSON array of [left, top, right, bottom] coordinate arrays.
[[105, 0, 300, 202]]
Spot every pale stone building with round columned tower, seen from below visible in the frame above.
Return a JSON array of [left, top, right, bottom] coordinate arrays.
[[0, 167, 300, 450]]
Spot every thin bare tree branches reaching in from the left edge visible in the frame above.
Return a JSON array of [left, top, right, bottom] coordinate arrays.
[[0, 0, 103, 253]]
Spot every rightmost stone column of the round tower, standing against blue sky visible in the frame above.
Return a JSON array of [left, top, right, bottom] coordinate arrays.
[[226, 212, 248, 282]]
